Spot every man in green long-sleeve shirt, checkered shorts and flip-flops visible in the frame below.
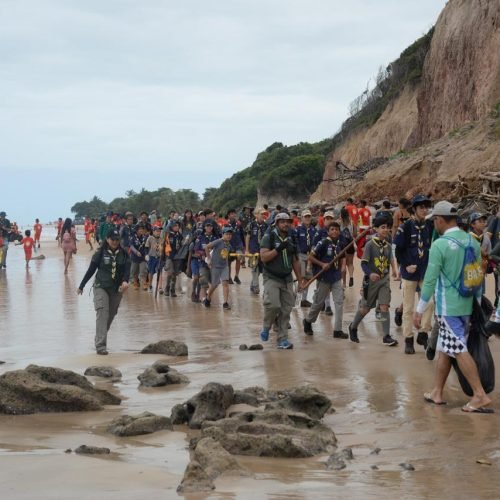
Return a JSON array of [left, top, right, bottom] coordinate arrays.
[[414, 201, 493, 413]]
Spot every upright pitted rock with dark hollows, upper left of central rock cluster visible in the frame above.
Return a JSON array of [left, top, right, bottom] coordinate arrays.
[[172, 382, 234, 429]]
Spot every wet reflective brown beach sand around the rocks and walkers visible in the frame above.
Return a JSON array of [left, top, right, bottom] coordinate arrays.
[[0, 238, 500, 499]]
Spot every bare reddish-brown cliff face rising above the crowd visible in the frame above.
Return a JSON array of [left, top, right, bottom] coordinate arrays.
[[311, 0, 500, 202]]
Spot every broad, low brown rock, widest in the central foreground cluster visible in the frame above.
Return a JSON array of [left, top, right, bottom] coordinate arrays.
[[202, 410, 337, 458]]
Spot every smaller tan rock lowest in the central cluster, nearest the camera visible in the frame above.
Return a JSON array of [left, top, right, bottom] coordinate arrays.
[[192, 438, 249, 480]]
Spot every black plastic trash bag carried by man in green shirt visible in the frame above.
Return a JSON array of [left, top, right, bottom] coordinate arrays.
[[451, 297, 495, 396]]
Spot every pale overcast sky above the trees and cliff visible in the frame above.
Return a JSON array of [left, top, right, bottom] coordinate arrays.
[[0, 0, 446, 224]]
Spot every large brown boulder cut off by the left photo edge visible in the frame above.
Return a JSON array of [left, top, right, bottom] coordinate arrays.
[[0, 365, 121, 415]]
